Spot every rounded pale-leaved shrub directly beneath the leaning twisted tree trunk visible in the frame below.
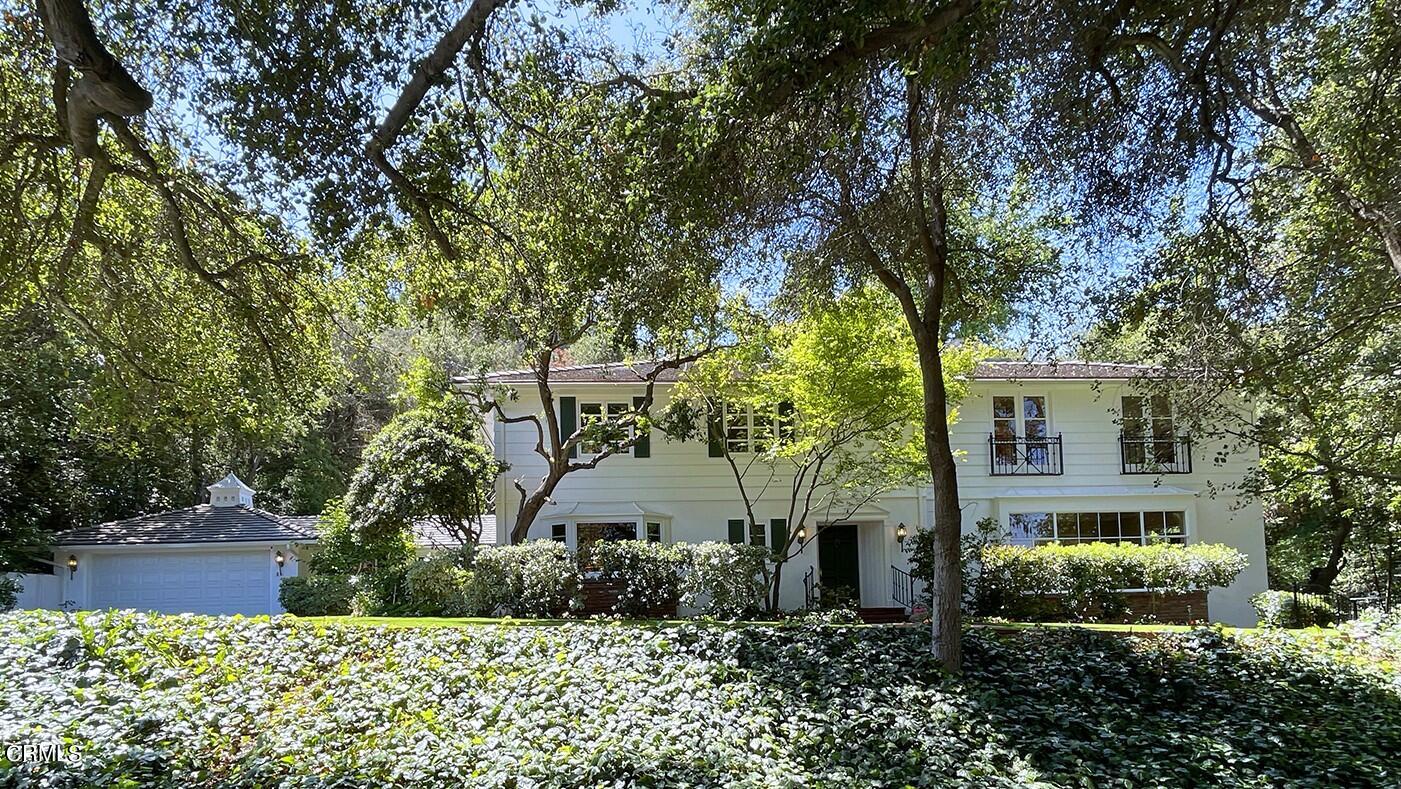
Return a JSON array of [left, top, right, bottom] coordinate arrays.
[[464, 540, 581, 617]]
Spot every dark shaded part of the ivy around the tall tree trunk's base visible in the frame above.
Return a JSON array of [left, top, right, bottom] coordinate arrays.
[[731, 628, 1401, 786]]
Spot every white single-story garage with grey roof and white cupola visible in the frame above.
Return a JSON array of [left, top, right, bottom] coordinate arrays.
[[55, 474, 315, 615]]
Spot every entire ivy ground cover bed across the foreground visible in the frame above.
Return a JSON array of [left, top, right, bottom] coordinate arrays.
[[0, 611, 1401, 788]]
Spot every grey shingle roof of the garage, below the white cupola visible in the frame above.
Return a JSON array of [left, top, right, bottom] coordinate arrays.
[[57, 505, 312, 545]]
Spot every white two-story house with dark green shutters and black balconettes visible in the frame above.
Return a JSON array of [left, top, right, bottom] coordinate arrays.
[[488, 362, 1265, 625]]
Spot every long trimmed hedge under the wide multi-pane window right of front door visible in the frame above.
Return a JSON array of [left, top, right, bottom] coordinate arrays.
[[976, 542, 1247, 621]]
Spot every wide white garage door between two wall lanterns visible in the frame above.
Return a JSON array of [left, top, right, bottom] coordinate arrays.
[[91, 551, 273, 614]]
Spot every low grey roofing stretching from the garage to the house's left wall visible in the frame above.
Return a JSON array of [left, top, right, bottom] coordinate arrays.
[[56, 505, 496, 548]]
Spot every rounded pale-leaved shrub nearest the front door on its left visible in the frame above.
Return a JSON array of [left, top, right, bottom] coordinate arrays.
[[681, 542, 769, 619]]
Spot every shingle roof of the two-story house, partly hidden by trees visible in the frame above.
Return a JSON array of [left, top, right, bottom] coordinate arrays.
[[470, 360, 1164, 384]]
